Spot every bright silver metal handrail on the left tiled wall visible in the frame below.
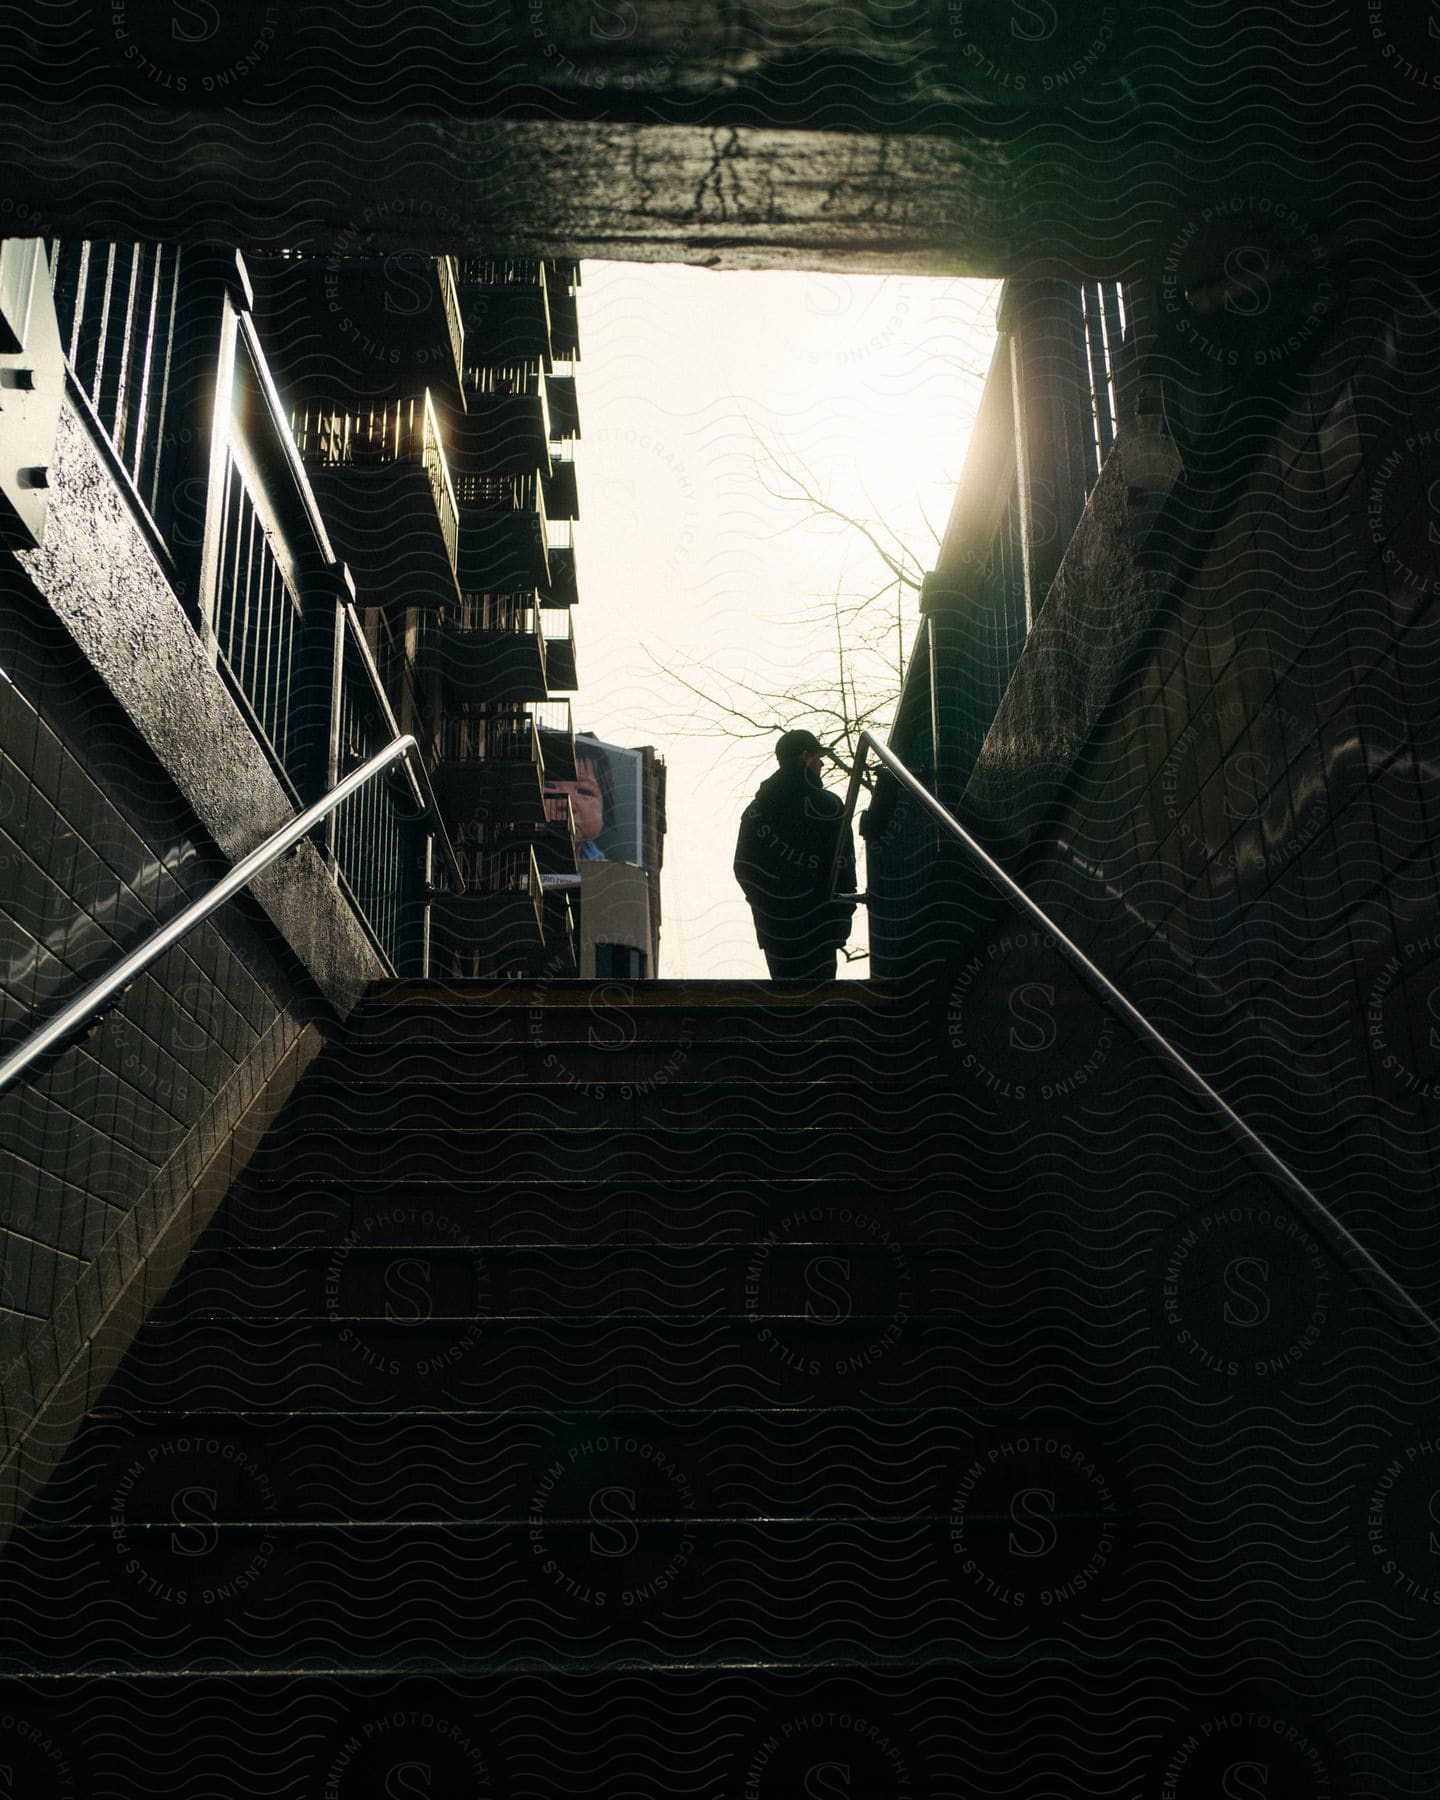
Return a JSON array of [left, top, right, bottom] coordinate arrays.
[[0, 733, 464, 1087]]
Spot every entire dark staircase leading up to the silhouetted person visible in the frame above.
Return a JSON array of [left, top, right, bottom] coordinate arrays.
[[0, 981, 1396, 1800]]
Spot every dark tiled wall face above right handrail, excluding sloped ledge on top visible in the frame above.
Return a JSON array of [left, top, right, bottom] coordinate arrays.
[[1012, 273, 1440, 1305]]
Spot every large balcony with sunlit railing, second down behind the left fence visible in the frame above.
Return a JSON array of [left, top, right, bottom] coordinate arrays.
[[292, 392, 459, 607]]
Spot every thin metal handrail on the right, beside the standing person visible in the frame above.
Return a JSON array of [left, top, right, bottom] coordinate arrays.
[[830, 731, 1440, 1352]]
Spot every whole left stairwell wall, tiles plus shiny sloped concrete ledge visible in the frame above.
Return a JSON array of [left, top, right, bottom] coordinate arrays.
[[0, 261, 399, 1517]]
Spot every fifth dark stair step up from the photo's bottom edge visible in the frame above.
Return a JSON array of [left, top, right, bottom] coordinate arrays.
[[162, 1245, 1049, 1321]]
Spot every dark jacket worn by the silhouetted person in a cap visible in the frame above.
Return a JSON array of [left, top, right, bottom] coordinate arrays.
[[734, 763, 855, 949]]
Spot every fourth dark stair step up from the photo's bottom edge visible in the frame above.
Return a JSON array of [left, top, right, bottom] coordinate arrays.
[[104, 1307, 1101, 1411]]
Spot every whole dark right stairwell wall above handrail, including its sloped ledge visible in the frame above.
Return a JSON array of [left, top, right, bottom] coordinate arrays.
[[952, 275, 1440, 1307]]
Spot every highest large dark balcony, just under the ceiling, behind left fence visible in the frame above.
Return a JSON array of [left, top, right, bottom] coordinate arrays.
[[247, 250, 466, 407]]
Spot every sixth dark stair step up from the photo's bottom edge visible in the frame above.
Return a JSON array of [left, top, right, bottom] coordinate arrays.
[[211, 1166, 993, 1246]]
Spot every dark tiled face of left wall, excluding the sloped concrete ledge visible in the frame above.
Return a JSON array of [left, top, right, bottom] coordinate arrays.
[[0, 572, 320, 1460]]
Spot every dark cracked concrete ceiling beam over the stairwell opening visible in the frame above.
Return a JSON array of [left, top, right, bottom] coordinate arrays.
[[0, 0, 1440, 275]]
